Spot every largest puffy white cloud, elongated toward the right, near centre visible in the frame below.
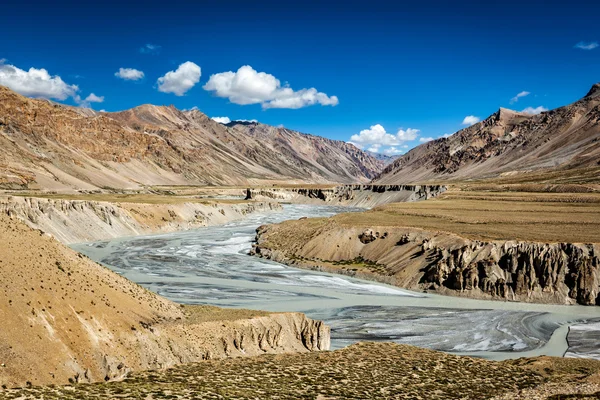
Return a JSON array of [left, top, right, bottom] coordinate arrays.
[[204, 65, 339, 109]]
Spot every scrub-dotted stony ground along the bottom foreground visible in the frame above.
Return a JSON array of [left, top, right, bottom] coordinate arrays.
[[0, 343, 600, 400]]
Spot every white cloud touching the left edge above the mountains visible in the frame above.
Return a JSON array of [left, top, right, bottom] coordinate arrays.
[[0, 60, 79, 100]]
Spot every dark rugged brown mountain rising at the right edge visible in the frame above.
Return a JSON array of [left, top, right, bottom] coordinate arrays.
[[374, 84, 600, 184]]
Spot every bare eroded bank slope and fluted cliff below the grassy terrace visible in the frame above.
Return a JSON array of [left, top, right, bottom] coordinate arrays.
[[253, 219, 600, 305]]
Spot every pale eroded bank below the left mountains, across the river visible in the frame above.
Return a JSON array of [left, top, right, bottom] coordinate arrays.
[[0, 196, 281, 244]]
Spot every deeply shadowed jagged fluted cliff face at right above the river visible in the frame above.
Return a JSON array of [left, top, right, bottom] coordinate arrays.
[[418, 237, 600, 305]]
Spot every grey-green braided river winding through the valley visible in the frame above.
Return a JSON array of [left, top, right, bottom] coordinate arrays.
[[72, 205, 600, 359]]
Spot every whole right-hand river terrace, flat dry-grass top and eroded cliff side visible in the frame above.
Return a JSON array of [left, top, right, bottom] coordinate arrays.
[[254, 191, 600, 305]]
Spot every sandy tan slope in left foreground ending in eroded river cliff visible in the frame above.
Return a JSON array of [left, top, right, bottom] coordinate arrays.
[[0, 215, 329, 387]]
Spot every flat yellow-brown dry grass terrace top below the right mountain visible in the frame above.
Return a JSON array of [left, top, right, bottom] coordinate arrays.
[[333, 190, 600, 243]]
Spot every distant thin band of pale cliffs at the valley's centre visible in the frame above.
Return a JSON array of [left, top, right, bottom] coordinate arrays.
[[246, 185, 446, 207]]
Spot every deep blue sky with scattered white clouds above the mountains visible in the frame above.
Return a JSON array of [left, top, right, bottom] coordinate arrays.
[[0, 0, 600, 152]]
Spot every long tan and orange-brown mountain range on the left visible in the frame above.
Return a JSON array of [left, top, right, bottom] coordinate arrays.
[[0, 87, 383, 190]]
